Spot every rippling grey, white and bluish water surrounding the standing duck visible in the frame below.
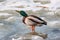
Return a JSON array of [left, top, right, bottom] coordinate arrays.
[[0, 0, 60, 40]]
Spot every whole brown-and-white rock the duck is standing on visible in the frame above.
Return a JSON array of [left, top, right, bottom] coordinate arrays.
[[12, 32, 47, 40]]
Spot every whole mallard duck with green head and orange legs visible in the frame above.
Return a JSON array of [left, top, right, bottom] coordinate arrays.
[[17, 11, 47, 32]]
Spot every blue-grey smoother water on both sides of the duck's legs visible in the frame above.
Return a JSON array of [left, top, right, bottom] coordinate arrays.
[[0, 12, 60, 40]]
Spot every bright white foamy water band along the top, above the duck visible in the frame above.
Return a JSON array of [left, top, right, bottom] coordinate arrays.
[[0, 0, 60, 11]]
